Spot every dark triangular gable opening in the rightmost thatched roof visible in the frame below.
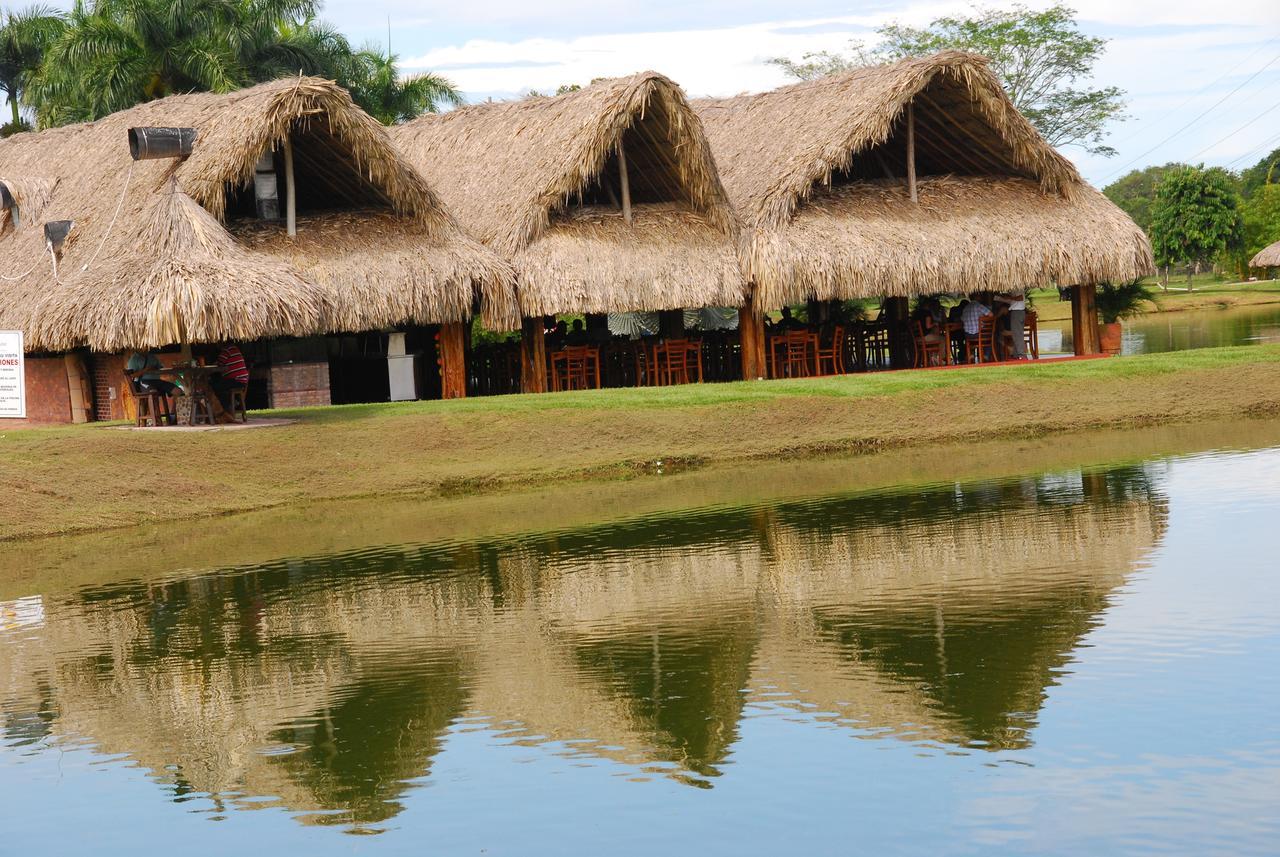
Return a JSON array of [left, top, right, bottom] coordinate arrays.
[[831, 78, 1033, 187]]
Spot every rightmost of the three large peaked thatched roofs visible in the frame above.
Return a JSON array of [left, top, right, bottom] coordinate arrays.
[[692, 51, 1152, 307]]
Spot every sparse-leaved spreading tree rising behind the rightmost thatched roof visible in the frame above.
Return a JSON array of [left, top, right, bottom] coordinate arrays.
[[769, 5, 1124, 156]]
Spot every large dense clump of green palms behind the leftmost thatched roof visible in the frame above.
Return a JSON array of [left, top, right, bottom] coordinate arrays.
[[26, 0, 344, 125]]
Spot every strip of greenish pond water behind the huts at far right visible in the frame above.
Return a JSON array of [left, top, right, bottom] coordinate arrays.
[[1041, 304, 1280, 354]]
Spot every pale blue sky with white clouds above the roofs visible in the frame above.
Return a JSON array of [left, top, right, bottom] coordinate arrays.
[[324, 0, 1280, 187]]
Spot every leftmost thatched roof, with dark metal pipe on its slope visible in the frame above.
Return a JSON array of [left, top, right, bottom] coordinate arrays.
[[0, 78, 518, 350]]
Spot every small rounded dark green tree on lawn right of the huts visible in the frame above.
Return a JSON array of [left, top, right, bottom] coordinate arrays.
[[1151, 166, 1242, 287]]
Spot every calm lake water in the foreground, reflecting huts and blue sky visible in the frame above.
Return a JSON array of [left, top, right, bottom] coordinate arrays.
[[0, 432, 1280, 854]]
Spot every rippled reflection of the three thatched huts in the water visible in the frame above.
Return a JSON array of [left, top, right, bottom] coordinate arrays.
[[0, 468, 1165, 824]]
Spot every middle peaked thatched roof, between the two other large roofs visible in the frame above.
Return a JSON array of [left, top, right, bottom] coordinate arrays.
[[392, 72, 744, 316]]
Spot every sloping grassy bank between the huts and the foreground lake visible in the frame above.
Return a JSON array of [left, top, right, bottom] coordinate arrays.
[[0, 347, 1280, 539]]
